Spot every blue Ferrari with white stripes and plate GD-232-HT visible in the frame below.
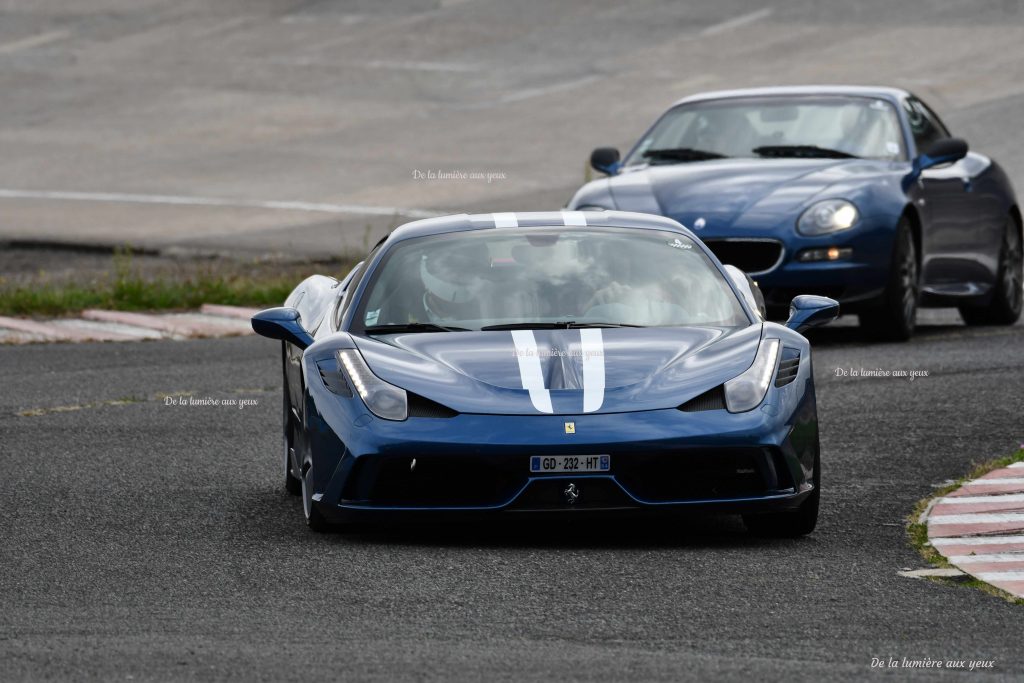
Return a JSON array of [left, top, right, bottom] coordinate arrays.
[[252, 211, 839, 536]]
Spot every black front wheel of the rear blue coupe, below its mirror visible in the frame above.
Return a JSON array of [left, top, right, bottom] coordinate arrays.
[[859, 216, 921, 341]]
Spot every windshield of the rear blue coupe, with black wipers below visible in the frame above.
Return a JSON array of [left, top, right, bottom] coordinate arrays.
[[625, 95, 905, 166]]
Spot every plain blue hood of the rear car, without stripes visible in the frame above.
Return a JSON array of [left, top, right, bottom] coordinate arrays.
[[608, 159, 882, 228]]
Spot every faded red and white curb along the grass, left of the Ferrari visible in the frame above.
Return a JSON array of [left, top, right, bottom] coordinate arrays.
[[0, 303, 259, 344]]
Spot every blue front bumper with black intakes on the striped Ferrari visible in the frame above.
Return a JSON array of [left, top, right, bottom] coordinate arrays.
[[303, 395, 818, 521]]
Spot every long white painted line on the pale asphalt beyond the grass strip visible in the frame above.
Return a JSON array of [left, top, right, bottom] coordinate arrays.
[[0, 188, 443, 218]]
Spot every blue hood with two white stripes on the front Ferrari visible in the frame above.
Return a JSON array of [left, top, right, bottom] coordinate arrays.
[[355, 324, 762, 415]]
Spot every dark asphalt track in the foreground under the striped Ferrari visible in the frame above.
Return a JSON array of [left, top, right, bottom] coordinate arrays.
[[0, 313, 1024, 681]]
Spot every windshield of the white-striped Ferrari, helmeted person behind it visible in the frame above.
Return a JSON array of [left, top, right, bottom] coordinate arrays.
[[353, 227, 750, 334]]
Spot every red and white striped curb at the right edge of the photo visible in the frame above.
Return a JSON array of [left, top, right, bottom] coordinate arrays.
[[926, 462, 1024, 598]]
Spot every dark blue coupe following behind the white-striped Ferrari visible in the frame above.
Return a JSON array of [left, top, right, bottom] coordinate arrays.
[[568, 86, 1024, 340]]
